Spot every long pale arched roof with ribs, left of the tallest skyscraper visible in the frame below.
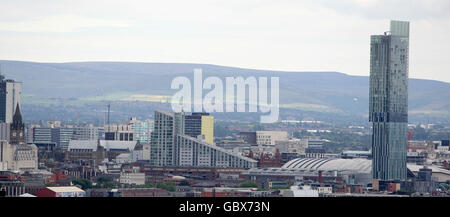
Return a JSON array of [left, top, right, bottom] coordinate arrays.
[[281, 158, 372, 173]]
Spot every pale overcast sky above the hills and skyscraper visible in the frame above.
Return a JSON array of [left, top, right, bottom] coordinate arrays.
[[0, 0, 450, 82]]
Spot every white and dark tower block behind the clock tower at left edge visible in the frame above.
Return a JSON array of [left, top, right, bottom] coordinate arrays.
[[0, 74, 22, 123]]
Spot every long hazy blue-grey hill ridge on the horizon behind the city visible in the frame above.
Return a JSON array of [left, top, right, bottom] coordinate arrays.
[[0, 60, 450, 119]]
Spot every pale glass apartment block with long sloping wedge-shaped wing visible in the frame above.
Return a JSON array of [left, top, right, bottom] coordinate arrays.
[[150, 111, 257, 168]]
